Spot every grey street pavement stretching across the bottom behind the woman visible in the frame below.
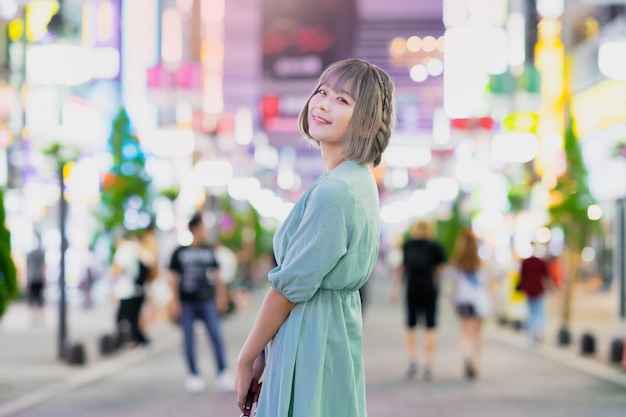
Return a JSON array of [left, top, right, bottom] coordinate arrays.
[[0, 282, 626, 417]]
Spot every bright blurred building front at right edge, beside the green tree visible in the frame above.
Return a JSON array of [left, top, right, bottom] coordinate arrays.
[[570, 6, 626, 314]]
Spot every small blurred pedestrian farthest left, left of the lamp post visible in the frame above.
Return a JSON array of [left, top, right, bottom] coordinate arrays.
[[26, 235, 46, 326]]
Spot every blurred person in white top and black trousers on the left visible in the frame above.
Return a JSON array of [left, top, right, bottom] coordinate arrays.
[[111, 231, 156, 349]]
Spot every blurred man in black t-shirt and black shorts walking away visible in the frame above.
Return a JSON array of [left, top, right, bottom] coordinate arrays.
[[390, 220, 446, 380]]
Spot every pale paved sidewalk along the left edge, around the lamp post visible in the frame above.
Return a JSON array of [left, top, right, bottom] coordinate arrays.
[[0, 301, 179, 416]]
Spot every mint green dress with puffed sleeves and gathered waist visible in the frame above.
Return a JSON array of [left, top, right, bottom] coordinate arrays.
[[257, 161, 380, 417]]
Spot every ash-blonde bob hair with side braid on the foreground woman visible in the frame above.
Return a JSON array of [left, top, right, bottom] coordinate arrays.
[[298, 58, 396, 166]]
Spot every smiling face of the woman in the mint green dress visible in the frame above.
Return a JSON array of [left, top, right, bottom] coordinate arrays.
[[308, 83, 356, 144]]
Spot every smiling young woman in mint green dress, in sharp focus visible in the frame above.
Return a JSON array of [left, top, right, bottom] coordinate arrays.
[[236, 59, 395, 417]]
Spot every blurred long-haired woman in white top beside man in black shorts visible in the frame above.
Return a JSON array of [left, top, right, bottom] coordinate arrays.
[[451, 230, 492, 379]]
